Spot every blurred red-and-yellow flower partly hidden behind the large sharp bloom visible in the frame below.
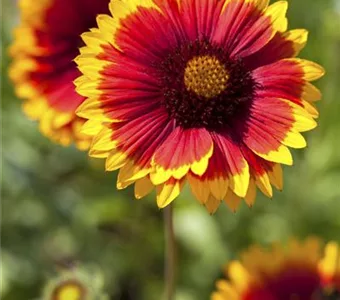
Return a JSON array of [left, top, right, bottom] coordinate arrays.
[[10, 0, 109, 149]]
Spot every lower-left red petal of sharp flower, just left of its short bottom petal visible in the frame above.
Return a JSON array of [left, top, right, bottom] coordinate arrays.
[[100, 110, 173, 184]]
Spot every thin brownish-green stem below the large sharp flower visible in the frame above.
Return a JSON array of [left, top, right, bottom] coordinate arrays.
[[164, 204, 176, 300]]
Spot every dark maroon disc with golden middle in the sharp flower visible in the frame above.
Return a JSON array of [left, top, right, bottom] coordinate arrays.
[[158, 40, 256, 130]]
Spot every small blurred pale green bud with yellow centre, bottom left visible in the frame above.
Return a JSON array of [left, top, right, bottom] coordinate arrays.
[[42, 267, 109, 300]]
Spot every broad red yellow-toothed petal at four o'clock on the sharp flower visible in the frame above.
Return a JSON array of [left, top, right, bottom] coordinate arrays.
[[244, 98, 316, 165]]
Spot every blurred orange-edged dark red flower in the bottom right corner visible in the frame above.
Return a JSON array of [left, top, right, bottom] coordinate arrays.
[[211, 238, 340, 300]]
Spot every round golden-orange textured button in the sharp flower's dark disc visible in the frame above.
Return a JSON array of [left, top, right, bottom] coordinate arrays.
[[184, 55, 229, 99]]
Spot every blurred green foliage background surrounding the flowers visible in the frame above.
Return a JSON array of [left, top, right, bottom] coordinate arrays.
[[0, 0, 340, 300]]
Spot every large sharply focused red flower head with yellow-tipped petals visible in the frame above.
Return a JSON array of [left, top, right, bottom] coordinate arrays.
[[75, 0, 324, 213]]
